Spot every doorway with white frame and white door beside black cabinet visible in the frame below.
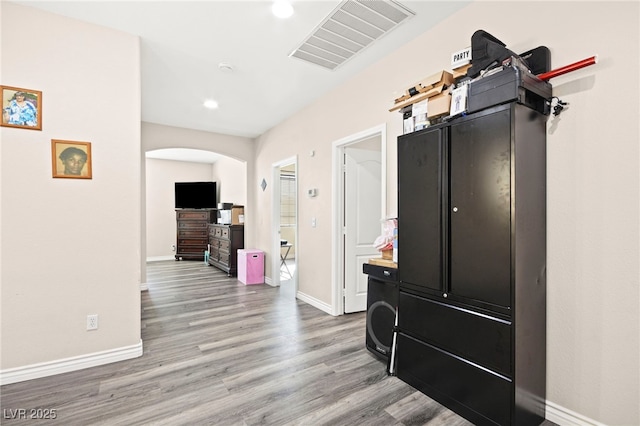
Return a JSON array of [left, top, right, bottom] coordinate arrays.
[[331, 124, 387, 315]]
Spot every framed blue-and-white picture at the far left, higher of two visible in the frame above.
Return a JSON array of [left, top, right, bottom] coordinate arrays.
[[0, 86, 42, 130]]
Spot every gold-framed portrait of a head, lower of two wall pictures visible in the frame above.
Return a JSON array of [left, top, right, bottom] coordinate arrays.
[[51, 139, 91, 179]]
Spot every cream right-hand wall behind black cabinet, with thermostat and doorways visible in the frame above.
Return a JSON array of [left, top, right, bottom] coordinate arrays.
[[249, 1, 640, 425]]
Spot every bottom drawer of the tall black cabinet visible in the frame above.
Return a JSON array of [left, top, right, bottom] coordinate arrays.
[[396, 333, 512, 425]]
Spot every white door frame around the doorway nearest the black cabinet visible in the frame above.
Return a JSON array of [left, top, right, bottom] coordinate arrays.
[[331, 123, 387, 315]]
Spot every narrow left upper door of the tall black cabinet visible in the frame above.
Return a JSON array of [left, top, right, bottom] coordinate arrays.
[[398, 128, 443, 291]]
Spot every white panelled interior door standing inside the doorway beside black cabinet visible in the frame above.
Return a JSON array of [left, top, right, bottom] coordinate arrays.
[[344, 144, 382, 313]]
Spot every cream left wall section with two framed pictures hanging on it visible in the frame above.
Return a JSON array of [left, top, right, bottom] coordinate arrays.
[[0, 2, 142, 372]]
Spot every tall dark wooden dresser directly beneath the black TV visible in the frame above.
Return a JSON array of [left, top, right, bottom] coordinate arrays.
[[176, 209, 216, 260]]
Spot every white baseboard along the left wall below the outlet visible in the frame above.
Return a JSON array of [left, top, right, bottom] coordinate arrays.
[[0, 340, 142, 385]]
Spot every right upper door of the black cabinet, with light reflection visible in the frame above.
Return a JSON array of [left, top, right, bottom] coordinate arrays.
[[450, 109, 511, 308]]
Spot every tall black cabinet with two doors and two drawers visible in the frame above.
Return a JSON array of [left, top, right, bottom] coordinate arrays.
[[396, 102, 547, 425]]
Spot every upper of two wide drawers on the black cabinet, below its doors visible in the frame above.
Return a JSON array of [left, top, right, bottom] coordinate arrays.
[[398, 292, 511, 377]]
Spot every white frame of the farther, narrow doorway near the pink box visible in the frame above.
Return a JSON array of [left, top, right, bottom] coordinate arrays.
[[271, 155, 299, 294]]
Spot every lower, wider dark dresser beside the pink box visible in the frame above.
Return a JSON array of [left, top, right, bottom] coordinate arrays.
[[209, 223, 244, 276]]
